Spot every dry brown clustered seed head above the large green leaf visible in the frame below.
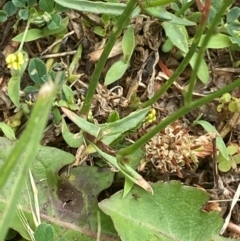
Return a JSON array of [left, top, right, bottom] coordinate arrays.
[[142, 123, 212, 173]]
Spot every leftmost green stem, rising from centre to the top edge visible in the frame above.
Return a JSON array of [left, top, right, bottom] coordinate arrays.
[[81, 0, 138, 116]]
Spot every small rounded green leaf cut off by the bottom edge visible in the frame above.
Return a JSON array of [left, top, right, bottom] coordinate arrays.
[[34, 223, 54, 241]]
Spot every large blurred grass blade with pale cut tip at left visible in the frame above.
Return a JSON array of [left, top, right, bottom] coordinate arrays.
[[0, 79, 56, 240]]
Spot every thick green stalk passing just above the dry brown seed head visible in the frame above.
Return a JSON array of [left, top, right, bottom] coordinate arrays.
[[118, 78, 240, 157]]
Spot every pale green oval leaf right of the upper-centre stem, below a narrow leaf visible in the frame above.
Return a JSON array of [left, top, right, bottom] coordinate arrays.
[[104, 60, 129, 85]]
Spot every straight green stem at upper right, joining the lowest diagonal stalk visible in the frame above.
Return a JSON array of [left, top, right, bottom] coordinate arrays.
[[185, 0, 232, 105]]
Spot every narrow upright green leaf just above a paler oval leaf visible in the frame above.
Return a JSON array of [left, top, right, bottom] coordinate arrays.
[[122, 25, 135, 63]]
